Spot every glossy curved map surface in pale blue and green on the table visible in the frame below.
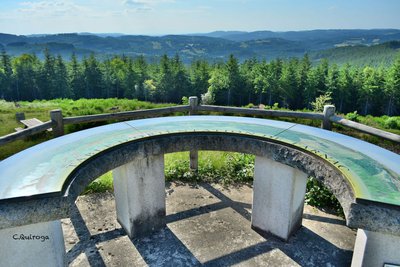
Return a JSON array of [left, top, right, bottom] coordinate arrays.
[[0, 116, 400, 206]]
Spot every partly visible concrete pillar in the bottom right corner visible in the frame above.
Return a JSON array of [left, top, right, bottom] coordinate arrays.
[[351, 229, 400, 267]]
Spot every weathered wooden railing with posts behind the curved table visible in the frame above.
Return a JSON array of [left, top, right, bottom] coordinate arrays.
[[0, 97, 400, 147]]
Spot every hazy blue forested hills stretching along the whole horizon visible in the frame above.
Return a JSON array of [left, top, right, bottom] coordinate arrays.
[[0, 29, 400, 64]]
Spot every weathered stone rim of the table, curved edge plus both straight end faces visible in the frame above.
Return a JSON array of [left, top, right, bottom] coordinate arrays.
[[0, 132, 400, 235]]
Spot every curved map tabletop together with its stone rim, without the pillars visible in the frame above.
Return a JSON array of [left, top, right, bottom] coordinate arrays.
[[0, 116, 400, 235]]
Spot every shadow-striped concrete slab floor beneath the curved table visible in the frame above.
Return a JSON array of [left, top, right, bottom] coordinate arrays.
[[62, 183, 356, 266]]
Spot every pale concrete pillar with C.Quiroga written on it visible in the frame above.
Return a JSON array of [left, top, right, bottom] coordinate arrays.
[[0, 221, 67, 267]]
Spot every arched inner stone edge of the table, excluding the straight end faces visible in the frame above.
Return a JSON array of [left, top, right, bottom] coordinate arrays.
[[65, 133, 354, 219]]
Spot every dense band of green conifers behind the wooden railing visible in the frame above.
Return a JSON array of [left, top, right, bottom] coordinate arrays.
[[0, 50, 400, 116]]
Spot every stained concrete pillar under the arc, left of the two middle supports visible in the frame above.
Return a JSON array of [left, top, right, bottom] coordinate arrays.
[[113, 154, 165, 238]]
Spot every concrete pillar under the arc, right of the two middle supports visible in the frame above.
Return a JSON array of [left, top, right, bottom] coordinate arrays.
[[251, 157, 307, 241]]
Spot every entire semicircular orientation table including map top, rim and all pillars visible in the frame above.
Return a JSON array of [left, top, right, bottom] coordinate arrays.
[[0, 116, 400, 266]]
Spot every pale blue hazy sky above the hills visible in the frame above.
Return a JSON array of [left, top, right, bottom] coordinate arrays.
[[0, 0, 400, 35]]
